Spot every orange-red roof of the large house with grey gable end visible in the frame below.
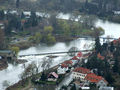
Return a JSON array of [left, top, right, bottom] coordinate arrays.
[[85, 73, 106, 83]]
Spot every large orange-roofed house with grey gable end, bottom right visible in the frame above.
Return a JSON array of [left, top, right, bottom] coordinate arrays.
[[85, 73, 108, 87]]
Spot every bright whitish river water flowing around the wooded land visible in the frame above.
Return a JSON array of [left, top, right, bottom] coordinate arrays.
[[0, 14, 120, 90]]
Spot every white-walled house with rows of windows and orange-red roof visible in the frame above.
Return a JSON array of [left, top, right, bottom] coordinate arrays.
[[72, 67, 91, 81]]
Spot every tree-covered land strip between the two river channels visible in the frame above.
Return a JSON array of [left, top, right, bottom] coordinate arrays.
[[0, 10, 104, 49]]
